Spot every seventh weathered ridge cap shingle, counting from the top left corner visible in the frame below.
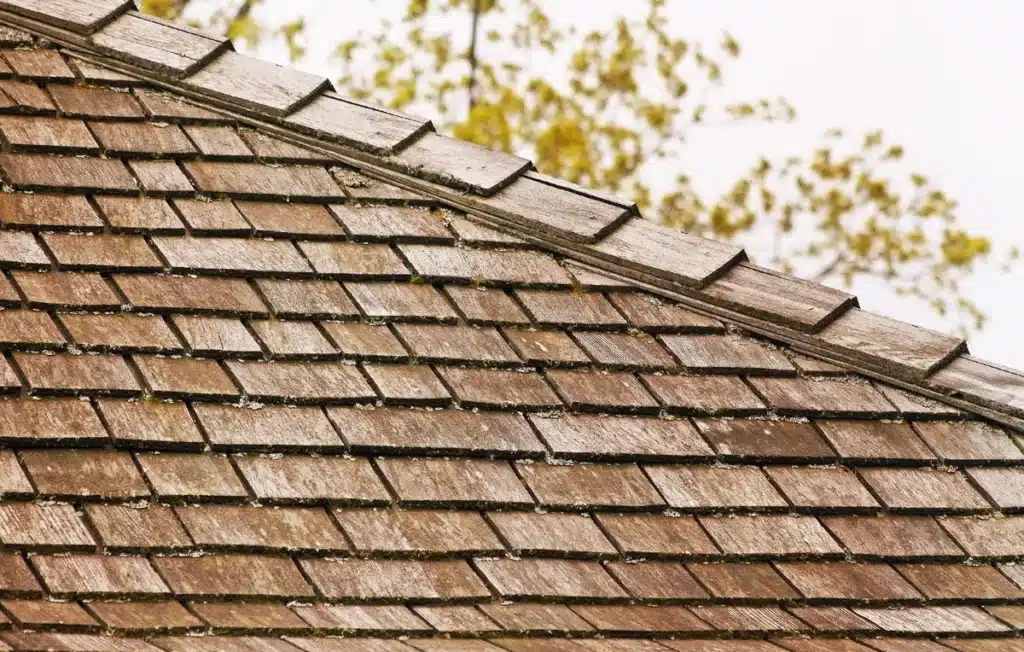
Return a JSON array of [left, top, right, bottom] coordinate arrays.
[[586, 218, 746, 288]]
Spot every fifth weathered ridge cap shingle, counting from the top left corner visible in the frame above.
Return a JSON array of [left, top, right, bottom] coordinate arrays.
[[390, 132, 532, 197]]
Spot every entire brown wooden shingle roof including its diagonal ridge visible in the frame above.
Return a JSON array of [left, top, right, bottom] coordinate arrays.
[[0, 0, 1024, 652]]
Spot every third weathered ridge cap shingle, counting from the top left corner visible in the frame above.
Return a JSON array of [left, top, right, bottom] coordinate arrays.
[[184, 52, 331, 116]]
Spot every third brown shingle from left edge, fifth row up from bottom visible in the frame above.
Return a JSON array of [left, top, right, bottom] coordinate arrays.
[[135, 453, 248, 499]]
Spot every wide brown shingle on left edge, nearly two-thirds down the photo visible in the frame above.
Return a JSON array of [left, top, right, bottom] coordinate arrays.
[[0, 398, 108, 445]]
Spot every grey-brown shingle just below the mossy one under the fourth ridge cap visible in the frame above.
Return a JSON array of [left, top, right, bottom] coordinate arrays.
[[331, 204, 455, 243]]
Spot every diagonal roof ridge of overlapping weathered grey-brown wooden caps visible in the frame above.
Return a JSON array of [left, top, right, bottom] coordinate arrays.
[[0, 0, 1024, 429]]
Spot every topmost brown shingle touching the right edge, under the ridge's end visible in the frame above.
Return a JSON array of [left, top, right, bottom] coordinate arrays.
[[914, 421, 1024, 464]]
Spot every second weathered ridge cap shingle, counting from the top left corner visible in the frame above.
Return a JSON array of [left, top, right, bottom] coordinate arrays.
[[92, 11, 231, 77]]
